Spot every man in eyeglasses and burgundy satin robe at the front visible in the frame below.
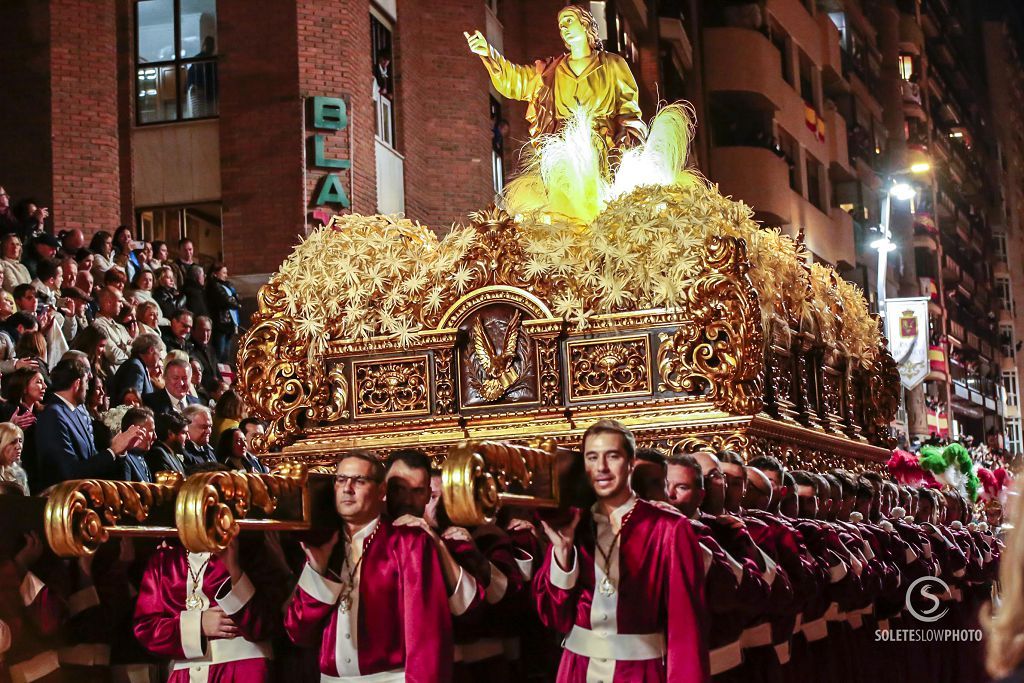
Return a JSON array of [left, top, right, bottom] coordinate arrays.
[[285, 451, 453, 683]]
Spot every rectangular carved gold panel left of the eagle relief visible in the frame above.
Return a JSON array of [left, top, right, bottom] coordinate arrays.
[[352, 354, 430, 420]]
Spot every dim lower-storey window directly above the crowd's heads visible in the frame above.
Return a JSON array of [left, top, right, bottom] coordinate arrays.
[[136, 203, 223, 264]]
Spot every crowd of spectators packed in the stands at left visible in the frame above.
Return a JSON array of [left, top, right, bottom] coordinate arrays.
[[0, 187, 264, 494]]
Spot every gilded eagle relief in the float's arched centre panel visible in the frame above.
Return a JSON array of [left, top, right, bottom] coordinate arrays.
[[461, 306, 537, 407]]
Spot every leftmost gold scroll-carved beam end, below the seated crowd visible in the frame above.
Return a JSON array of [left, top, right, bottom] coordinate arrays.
[[45, 479, 180, 557]]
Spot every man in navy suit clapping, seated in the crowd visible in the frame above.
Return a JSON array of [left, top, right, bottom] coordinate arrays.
[[32, 357, 143, 490]]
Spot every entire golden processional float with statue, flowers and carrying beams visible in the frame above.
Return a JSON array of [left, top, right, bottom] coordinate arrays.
[[37, 6, 900, 555]]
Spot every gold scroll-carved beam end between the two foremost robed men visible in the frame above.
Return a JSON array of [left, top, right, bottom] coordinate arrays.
[[441, 441, 558, 525]]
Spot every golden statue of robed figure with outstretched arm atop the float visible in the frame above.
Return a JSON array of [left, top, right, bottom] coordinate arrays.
[[464, 5, 647, 148]]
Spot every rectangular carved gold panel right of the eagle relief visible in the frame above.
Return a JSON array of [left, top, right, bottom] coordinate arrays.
[[566, 335, 652, 400]]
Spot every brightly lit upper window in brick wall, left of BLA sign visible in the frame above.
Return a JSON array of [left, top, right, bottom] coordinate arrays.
[[135, 0, 217, 124]]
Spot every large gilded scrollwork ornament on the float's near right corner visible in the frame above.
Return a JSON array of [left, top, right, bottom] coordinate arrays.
[[657, 237, 764, 415]]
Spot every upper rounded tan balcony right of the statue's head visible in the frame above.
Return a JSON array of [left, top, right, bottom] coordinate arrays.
[[703, 27, 790, 112]]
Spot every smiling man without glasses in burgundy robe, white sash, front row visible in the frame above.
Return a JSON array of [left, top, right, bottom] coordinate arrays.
[[534, 420, 709, 683]]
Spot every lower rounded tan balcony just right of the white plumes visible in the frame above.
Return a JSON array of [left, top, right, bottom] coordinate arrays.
[[711, 146, 796, 225]]
